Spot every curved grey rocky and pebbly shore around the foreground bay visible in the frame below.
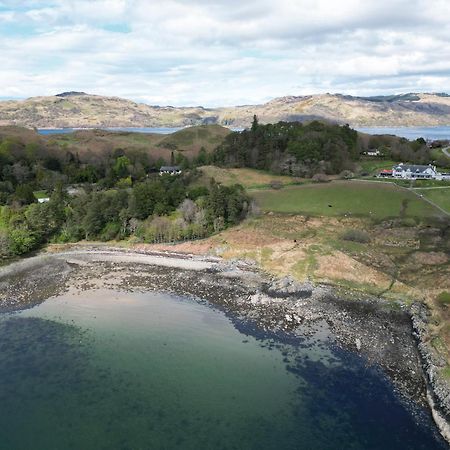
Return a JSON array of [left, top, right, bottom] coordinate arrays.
[[0, 248, 450, 440]]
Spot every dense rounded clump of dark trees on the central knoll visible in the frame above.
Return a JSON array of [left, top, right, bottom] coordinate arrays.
[[214, 116, 361, 176]]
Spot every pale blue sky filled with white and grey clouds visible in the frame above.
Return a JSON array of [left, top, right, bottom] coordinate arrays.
[[0, 0, 450, 107]]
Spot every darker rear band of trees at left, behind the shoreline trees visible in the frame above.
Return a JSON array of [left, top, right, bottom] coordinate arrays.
[[0, 137, 157, 204]]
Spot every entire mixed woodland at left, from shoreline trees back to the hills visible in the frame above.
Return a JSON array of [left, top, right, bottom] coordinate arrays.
[[0, 130, 249, 258]]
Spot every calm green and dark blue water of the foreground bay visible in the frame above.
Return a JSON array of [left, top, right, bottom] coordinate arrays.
[[0, 291, 447, 450]]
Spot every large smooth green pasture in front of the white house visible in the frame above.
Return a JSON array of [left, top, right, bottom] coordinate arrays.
[[252, 181, 442, 219]]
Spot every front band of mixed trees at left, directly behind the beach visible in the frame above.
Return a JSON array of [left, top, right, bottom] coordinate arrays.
[[0, 176, 249, 258]]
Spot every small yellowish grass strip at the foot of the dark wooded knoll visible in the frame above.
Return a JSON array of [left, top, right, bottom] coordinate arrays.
[[197, 166, 294, 189]]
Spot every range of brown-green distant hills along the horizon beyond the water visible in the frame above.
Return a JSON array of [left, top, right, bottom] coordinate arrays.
[[0, 92, 450, 128]]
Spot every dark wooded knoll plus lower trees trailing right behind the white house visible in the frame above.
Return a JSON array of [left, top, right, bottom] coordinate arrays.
[[213, 116, 448, 177]]
